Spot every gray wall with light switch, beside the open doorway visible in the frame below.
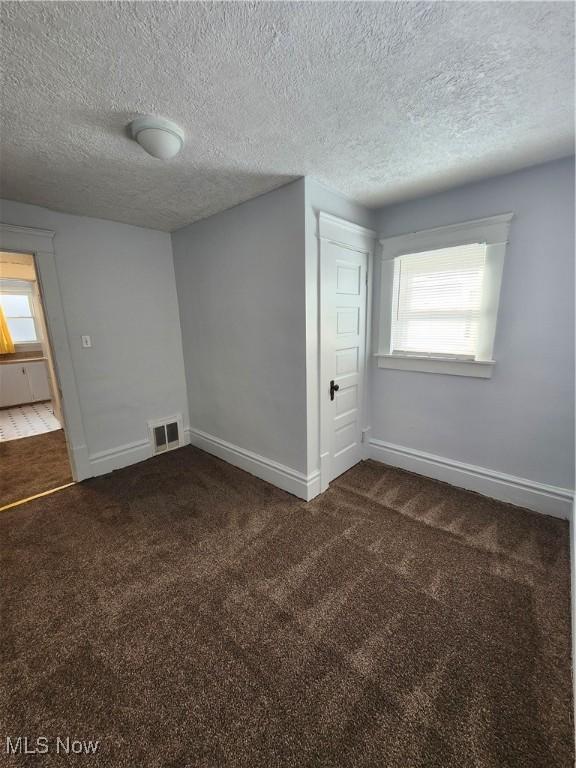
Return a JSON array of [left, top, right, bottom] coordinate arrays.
[[0, 200, 188, 462]]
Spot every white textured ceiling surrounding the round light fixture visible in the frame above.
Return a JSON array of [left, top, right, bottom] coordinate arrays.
[[0, 2, 574, 230]]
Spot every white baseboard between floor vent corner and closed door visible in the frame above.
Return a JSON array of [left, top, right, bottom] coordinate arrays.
[[190, 429, 320, 501]]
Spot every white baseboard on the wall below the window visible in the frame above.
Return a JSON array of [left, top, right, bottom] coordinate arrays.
[[369, 438, 574, 520]]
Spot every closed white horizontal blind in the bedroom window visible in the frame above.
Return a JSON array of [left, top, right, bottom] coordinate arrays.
[[390, 243, 486, 359]]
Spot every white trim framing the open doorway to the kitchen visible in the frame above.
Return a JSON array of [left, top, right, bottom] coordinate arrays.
[[0, 222, 90, 481]]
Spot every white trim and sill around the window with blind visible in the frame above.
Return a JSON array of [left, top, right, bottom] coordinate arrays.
[[374, 213, 514, 379]]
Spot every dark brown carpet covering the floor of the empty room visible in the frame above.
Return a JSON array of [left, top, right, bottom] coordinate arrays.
[[0, 448, 572, 768]]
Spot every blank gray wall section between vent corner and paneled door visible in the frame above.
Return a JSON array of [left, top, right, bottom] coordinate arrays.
[[172, 180, 307, 472]]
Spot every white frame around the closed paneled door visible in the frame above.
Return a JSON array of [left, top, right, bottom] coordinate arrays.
[[318, 211, 378, 492]]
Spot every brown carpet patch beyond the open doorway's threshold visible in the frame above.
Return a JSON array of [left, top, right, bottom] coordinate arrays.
[[0, 429, 72, 507]]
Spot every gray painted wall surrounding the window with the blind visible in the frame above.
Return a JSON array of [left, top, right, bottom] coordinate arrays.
[[371, 158, 574, 488]]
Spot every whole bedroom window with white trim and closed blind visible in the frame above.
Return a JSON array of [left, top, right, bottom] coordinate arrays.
[[376, 214, 511, 378]]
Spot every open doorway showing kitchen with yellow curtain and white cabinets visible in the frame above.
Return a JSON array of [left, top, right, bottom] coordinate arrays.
[[0, 251, 72, 508]]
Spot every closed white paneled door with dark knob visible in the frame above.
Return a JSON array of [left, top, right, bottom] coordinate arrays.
[[320, 214, 373, 487]]
